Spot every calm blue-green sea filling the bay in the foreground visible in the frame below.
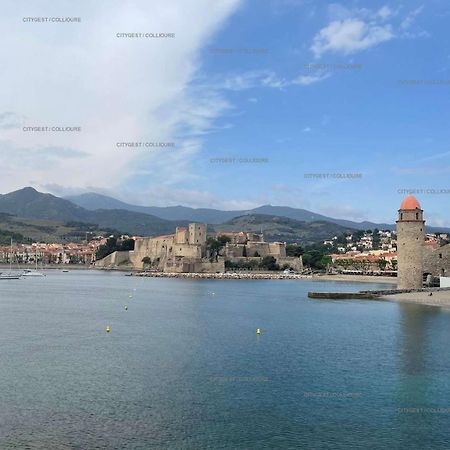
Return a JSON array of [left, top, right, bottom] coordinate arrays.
[[0, 271, 450, 450]]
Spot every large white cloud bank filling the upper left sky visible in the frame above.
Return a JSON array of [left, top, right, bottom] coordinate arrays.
[[0, 0, 241, 192]]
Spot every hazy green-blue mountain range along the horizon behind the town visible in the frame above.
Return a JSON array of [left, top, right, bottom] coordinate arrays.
[[0, 187, 450, 243]]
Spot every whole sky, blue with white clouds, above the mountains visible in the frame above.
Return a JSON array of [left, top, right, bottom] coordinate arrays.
[[0, 0, 450, 226]]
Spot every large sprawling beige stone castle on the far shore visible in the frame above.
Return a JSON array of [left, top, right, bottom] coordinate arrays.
[[96, 223, 303, 273]]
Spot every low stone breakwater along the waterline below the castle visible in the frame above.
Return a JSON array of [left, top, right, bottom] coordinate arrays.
[[133, 272, 311, 280]]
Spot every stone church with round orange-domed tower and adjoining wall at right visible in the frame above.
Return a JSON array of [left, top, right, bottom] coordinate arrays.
[[397, 195, 450, 289]]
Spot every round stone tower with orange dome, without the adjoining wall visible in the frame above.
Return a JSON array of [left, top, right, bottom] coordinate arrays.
[[397, 195, 425, 289]]
